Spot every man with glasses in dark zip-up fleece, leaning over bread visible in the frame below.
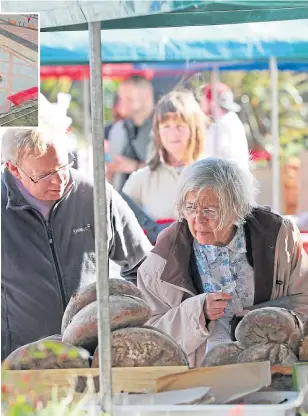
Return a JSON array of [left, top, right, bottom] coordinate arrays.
[[1, 126, 152, 359]]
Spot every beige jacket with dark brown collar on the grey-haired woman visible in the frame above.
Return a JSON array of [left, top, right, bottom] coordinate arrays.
[[137, 208, 308, 366]]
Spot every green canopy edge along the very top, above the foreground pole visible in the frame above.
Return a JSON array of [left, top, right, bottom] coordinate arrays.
[[1, 0, 308, 31]]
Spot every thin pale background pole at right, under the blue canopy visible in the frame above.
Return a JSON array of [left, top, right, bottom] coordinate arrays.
[[270, 57, 280, 213]]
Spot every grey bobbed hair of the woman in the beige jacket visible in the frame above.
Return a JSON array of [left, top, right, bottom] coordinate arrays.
[[176, 158, 258, 229]]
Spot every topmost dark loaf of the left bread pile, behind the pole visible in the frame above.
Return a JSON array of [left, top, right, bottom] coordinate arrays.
[[61, 278, 146, 334]]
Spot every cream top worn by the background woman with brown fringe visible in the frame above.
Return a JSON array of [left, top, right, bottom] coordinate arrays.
[[123, 162, 179, 221]]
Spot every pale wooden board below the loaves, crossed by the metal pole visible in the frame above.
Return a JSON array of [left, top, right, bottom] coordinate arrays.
[[4, 366, 188, 396]]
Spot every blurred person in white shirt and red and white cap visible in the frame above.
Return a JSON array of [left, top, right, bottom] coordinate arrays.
[[200, 83, 249, 169]]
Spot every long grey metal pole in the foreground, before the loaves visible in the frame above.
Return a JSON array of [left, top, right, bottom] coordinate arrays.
[[89, 22, 112, 416]]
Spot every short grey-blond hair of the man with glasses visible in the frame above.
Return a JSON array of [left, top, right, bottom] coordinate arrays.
[[1, 128, 65, 164]]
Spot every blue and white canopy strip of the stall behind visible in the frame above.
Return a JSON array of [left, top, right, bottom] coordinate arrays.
[[40, 19, 308, 65]]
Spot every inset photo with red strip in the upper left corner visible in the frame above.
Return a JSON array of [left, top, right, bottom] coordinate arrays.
[[0, 13, 40, 127]]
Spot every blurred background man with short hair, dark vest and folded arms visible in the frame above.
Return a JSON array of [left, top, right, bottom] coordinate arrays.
[[107, 75, 154, 191]]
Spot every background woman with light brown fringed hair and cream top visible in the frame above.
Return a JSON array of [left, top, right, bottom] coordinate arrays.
[[123, 91, 206, 242]]
